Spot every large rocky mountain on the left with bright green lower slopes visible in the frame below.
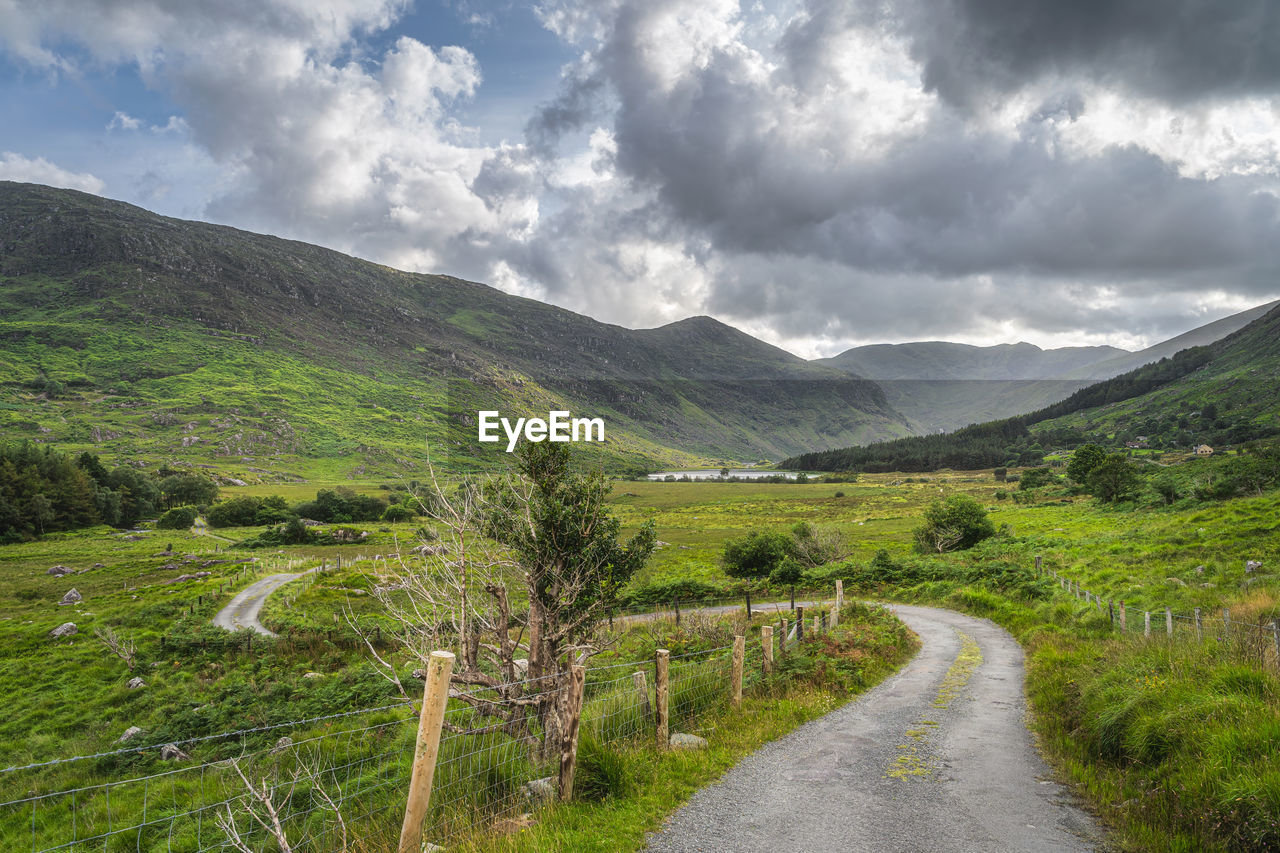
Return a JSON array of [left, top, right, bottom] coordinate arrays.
[[0, 182, 909, 480]]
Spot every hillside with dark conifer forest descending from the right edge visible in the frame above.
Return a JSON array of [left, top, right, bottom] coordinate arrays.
[[782, 298, 1280, 471]]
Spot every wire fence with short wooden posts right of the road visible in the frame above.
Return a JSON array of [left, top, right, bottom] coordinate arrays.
[[1042, 560, 1280, 670]]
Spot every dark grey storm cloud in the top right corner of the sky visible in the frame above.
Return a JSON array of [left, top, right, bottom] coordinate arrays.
[[890, 0, 1280, 106]]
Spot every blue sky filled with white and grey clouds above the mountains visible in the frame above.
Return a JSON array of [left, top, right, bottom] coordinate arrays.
[[0, 0, 1280, 356]]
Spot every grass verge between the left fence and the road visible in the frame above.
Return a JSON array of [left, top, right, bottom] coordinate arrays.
[[451, 605, 919, 853]]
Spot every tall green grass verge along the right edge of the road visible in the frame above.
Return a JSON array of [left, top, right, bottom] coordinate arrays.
[[893, 579, 1280, 852]]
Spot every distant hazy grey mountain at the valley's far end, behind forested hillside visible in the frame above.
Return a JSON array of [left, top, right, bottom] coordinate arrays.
[[815, 302, 1280, 434]]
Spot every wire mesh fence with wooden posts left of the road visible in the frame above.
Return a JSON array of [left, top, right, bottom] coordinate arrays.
[[0, 617, 829, 853]]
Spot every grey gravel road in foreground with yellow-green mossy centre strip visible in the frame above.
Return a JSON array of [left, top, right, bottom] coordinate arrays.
[[648, 606, 1105, 853]]
